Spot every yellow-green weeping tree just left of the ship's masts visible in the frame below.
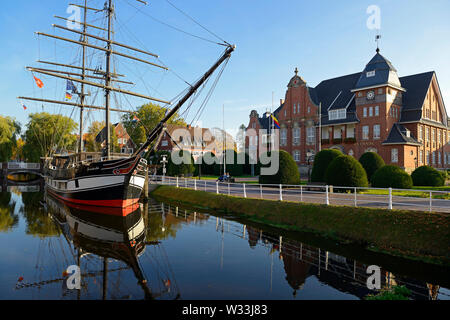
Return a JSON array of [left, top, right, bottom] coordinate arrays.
[[23, 112, 77, 162]]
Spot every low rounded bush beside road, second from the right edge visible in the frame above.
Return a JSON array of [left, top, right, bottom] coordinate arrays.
[[372, 165, 413, 189]]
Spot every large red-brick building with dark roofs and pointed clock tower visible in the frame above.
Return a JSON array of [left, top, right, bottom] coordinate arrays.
[[246, 49, 450, 172]]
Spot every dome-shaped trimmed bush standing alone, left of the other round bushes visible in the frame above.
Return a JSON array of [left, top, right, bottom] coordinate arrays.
[[259, 150, 300, 184]]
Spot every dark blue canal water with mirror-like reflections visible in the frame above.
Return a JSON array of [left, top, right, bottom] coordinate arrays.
[[0, 187, 450, 300]]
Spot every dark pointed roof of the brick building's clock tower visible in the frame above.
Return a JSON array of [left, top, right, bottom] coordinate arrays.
[[353, 52, 401, 89]]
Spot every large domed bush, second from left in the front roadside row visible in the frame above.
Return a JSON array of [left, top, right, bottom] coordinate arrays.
[[325, 155, 369, 187]]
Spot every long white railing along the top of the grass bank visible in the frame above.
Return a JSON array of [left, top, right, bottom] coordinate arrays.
[[149, 176, 450, 213]]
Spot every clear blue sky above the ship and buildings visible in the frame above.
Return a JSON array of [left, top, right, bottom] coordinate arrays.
[[0, 0, 450, 133]]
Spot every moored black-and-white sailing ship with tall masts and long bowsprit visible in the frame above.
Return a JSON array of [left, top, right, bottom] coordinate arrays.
[[18, 0, 235, 215]]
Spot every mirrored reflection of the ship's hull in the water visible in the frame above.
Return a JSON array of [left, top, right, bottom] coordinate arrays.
[[24, 196, 179, 299]]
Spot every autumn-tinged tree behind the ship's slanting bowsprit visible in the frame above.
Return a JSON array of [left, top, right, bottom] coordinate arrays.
[[122, 103, 186, 146]]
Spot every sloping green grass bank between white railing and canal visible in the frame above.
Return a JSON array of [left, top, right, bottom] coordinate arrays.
[[152, 186, 450, 266]]
